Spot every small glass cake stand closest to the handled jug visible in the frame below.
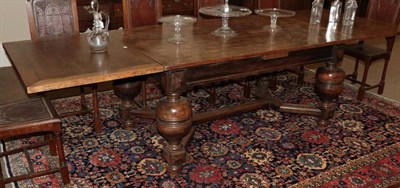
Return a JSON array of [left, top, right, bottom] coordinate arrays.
[[158, 15, 197, 44]]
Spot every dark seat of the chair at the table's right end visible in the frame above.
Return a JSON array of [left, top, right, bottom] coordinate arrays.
[[344, 44, 389, 63]]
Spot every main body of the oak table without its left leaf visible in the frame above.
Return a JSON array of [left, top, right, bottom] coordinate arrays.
[[110, 11, 399, 175]]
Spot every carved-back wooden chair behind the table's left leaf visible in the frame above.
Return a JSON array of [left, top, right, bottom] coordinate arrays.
[[26, 0, 101, 132]]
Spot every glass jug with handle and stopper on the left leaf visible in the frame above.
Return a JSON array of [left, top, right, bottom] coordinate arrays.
[[87, 0, 110, 53]]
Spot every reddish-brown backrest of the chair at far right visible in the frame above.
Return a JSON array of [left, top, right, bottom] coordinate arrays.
[[367, 0, 400, 25]]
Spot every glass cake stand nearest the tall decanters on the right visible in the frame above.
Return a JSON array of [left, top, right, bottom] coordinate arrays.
[[254, 8, 296, 31]]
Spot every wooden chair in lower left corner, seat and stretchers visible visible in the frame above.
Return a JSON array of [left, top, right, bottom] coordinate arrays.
[[0, 98, 70, 188]]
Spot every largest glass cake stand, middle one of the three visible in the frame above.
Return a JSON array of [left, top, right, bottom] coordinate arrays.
[[199, 0, 252, 37]]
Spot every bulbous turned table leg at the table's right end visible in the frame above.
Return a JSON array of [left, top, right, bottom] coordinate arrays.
[[314, 46, 345, 127]]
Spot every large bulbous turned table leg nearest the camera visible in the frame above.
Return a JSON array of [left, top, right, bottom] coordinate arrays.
[[156, 93, 192, 176]]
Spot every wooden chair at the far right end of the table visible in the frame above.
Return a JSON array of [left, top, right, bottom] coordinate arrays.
[[344, 0, 400, 101]]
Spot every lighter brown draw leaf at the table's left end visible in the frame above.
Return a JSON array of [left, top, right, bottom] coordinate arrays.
[[3, 30, 163, 131]]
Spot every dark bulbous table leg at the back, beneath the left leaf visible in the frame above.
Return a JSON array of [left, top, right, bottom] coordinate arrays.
[[114, 78, 142, 130]]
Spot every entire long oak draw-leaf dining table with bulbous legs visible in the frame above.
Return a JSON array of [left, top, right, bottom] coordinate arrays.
[[3, 11, 400, 175]]
